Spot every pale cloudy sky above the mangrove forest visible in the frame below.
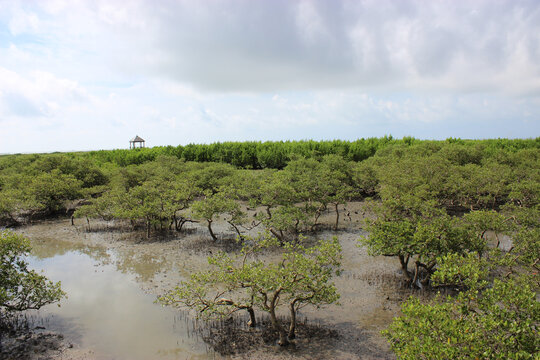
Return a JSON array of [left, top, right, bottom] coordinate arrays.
[[0, 0, 540, 153]]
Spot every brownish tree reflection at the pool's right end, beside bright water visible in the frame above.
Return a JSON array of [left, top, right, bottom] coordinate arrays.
[[116, 250, 170, 281]]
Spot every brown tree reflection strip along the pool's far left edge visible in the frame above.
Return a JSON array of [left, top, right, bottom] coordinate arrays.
[[30, 238, 110, 263]]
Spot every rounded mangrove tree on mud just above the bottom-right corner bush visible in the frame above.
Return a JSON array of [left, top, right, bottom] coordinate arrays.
[[361, 205, 511, 287]]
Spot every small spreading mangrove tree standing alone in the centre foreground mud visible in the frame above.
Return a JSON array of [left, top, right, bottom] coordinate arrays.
[[159, 236, 341, 345]]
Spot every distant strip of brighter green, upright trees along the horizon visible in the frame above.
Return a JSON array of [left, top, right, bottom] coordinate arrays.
[[7, 136, 540, 169]]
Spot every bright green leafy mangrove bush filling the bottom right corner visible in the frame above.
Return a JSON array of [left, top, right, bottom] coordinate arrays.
[[384, 248, 540, 359]]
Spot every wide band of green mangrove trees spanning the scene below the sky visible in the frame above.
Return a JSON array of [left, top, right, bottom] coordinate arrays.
[[0, 137, 540, 229]]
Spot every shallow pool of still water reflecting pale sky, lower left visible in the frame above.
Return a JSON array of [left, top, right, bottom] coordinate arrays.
[[25, 241, 216, 360]]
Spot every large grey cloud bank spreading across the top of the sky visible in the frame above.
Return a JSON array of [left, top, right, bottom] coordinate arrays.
[[2, 0, 540, 94]]
